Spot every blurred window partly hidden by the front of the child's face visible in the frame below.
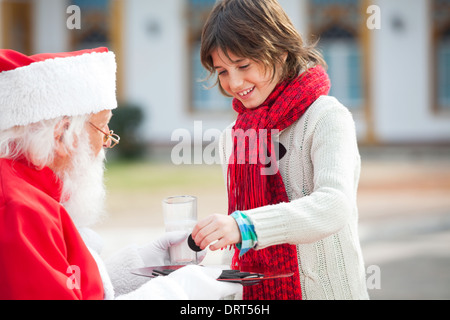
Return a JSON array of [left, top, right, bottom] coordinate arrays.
[[188, 0, 231, 112]]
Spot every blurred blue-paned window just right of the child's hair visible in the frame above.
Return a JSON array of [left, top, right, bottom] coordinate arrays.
[[310, 0, 364, 110]]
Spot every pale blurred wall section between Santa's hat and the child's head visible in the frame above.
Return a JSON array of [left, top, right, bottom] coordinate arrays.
[[124, 0, 231, 143]]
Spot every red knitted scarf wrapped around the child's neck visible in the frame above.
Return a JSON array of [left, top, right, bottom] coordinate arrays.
[[228, 66, 330, 300]]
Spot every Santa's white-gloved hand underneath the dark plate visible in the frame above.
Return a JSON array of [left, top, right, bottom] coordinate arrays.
[[168, 265, 242, 300]]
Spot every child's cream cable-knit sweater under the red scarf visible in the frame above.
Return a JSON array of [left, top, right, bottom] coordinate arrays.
[[220, 96, 369, 300]]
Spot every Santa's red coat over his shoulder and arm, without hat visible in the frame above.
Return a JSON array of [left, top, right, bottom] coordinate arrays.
[[0, 159, 103, 299]]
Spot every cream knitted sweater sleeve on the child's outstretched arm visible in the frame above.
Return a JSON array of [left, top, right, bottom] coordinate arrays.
[[244, 103, 359, 249]]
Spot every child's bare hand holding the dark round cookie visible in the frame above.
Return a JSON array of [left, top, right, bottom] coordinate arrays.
[[192, 214, 242, 251]]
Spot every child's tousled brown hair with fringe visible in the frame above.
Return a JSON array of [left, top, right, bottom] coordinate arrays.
[[200, 0, 326, 96]]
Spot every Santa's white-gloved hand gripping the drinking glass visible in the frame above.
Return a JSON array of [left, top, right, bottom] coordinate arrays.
[[139, 231, 206, 266]]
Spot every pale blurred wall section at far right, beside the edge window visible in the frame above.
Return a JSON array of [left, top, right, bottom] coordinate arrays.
[[373, 0, 450, 142]]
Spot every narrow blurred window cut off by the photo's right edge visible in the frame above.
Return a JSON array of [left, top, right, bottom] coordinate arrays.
[[432, 0, 450, 111]]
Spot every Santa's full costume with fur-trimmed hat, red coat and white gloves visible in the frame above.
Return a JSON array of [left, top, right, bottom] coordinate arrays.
[[0, 47, 243, 300]]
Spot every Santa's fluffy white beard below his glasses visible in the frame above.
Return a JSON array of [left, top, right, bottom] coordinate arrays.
[[60, 136, 106, 228]]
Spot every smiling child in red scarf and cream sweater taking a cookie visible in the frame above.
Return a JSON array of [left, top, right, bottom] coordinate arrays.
[[193, 0, 368, 300]]
